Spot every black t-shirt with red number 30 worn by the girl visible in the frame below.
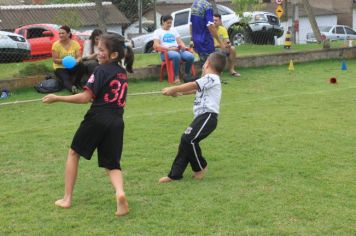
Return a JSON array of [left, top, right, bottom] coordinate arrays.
[[84, 62, 128, 112]]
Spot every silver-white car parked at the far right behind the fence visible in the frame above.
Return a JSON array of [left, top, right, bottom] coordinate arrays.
[[306, 25, 356, 43]]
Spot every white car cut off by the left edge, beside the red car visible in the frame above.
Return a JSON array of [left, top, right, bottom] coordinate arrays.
[[0, 31, 31, 62]]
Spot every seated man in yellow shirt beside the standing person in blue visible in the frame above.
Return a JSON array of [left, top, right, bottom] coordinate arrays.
[[214, 14, 240, 77]]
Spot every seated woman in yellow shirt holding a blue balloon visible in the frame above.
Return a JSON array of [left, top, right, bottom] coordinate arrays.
[[52, 25, 84, 94]]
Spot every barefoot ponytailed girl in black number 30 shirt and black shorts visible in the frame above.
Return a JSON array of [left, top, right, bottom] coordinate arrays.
[[42, 34, 134, 216]]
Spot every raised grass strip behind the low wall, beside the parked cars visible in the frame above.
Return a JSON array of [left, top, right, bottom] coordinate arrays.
[[0, 42, 343, 80]]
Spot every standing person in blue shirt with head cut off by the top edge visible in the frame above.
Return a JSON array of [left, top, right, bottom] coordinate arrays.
[[190, 0, 225, 66]]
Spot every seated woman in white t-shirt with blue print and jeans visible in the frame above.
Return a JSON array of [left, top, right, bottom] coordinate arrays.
[[153, 15, 194, 83]]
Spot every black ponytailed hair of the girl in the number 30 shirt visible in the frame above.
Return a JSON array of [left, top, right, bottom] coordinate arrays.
[[100, 33, 134, 73]]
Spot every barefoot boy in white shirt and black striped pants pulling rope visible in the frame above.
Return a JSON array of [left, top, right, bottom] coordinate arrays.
[[159, 52, 226, 183]]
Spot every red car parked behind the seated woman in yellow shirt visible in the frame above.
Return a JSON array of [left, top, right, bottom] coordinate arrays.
[[15, 24, 90, 58]]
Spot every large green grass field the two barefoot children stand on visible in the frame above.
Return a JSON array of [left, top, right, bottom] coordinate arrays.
[[0, 60, 356, 236]]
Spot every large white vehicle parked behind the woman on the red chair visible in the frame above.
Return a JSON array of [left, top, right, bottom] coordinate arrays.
[[131, 4, 283, 53]]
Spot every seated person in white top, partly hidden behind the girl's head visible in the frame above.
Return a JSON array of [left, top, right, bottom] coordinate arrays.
[[82, 29, 103, 82]]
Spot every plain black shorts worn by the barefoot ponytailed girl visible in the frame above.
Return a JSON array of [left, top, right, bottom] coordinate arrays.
[[71, 110, 125, 170]]
